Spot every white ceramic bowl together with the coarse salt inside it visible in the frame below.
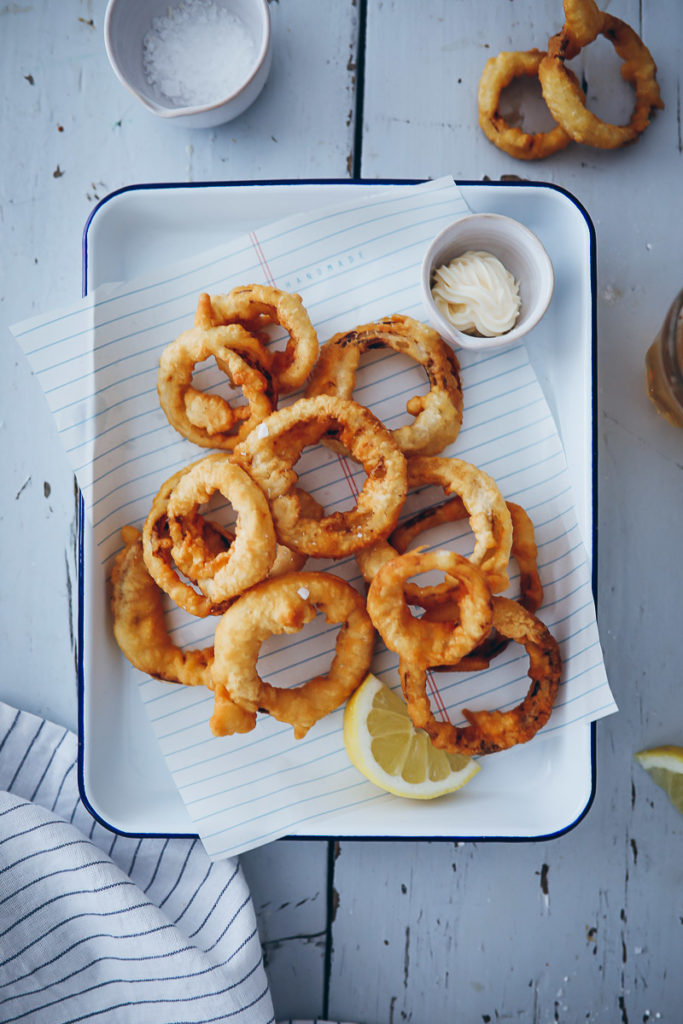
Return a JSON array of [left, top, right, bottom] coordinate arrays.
[[104, 0, 271, 128]]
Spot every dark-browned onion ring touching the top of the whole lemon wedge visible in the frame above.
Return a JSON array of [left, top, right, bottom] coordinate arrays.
[[398, 598, 561, 757]]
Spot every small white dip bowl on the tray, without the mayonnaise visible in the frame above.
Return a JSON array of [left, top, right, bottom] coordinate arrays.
[[422, 213, 555, 349]]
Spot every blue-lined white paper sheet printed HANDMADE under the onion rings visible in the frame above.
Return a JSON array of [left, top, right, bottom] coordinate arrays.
[[7, 178, 615, 857]]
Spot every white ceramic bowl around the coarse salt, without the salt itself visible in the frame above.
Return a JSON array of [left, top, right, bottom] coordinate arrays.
[[104, 0, 271, 128]]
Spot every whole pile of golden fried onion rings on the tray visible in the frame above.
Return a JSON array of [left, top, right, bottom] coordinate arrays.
[[112, 286, 559, 754]]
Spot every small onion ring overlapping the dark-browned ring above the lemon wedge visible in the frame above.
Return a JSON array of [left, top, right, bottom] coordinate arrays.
[[367, 548, 493, 666]]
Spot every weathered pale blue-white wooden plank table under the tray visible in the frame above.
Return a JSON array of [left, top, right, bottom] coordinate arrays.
[[0, 0, 683, 1024]]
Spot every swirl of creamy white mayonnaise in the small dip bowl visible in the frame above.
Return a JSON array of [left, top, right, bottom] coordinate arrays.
[[432, 251, 520, 338]]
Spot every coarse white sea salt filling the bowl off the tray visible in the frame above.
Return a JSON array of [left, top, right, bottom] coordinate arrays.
[[142, 0, 256, 106]]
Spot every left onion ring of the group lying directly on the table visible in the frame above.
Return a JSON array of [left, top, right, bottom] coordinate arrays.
[[477, 49, 583, 160]]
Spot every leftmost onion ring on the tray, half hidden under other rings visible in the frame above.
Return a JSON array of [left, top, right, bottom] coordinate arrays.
[[112, 526, 256, 732]]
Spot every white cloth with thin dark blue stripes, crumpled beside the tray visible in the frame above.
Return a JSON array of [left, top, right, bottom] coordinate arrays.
[[0, 703, 273, 1024]]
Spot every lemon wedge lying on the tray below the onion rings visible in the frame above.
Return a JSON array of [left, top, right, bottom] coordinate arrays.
[[344, 673, 480, 800]]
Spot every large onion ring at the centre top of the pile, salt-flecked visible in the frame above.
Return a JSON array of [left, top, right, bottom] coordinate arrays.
[[233, 395, 407, 558]]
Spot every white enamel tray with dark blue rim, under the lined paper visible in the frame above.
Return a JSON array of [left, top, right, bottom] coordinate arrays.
[[79, 181, 596, 840]]
